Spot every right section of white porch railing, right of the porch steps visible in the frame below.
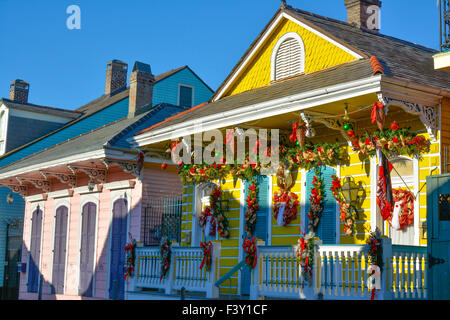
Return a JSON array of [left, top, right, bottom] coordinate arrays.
[[250, 239, 427, 300]]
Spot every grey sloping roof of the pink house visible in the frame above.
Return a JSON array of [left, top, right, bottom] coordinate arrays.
[[0, 103, 186, 174]]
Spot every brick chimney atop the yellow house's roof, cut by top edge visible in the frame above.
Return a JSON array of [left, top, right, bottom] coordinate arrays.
[[345, 0, 381, 32]]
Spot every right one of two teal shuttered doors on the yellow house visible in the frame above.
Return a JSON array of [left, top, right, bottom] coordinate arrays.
[[304, 167, 337, 244]]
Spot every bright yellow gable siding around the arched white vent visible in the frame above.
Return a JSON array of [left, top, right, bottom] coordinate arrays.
[[224, 18, 356, 96]]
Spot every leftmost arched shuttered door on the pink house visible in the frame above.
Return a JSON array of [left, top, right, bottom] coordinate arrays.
[[27, 210, 42, 292]]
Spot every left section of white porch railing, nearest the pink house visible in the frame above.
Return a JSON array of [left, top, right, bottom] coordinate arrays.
[[130, 242, 220, 298]]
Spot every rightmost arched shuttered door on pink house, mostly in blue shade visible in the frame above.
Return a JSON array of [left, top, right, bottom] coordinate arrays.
[[109, 199, 128, 300]]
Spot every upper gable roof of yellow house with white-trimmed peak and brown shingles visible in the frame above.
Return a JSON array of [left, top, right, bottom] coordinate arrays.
[[210, 6, 450, 101]]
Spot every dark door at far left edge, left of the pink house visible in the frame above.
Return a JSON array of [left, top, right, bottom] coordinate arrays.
[[2, 223, 23, 300]]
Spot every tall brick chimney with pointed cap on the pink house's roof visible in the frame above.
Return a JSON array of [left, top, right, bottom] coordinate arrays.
[[128, 61, 155, 118]]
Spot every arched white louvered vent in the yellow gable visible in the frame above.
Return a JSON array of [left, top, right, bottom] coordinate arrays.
[[271, 32, 305, 81]]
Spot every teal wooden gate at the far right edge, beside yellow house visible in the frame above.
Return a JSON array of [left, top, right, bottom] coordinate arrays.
[[427, 175, 450, 300]]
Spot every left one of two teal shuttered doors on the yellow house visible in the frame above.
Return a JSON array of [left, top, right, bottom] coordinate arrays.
[[241, 176, 269, 295]]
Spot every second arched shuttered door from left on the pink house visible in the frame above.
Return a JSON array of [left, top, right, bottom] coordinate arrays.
[[52, 206, 69, 294]]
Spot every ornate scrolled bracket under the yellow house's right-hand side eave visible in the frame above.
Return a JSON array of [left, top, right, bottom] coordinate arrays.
[[378, 95, 439, 140]]
